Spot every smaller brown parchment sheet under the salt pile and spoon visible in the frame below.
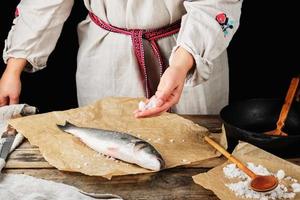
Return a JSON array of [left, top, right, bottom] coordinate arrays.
[[193, 142, 300, 200]]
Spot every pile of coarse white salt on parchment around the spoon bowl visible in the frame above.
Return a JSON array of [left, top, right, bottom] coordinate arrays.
[[223, 163, 300, 200]]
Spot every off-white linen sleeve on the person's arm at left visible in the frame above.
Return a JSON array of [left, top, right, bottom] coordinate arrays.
[[3, 0, 74, 72]]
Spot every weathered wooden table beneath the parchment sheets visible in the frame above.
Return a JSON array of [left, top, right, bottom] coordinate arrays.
[[3, 115, 300, 200]]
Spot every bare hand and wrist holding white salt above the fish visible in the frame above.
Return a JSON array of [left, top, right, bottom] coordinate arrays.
[[134, 47, 194, 118]]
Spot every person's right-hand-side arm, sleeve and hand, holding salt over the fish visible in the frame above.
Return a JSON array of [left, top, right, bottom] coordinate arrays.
[[135, 0, 242, 117]]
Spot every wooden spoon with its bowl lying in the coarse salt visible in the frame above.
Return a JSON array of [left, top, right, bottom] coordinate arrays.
[[204, 136, 278, 192]]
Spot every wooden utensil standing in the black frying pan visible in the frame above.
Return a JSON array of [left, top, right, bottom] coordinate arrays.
[[265, 77, 299, 136]]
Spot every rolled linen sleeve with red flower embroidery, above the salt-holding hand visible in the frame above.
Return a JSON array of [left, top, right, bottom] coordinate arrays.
[[170, 0, 242, 86]]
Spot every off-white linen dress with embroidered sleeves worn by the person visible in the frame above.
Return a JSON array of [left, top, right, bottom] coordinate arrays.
[[3, 0, 242, 114]]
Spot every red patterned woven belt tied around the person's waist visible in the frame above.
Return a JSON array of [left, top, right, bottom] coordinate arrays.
[[89, 12, 180, 98]]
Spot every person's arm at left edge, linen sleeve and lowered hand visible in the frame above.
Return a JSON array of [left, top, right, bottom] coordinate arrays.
[[0, 0, 73, 106]]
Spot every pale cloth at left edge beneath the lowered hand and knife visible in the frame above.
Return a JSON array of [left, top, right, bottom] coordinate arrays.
[[0, 104, 36, 172]]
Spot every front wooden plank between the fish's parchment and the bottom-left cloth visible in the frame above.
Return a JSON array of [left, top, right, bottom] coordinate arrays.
[[4, 168, 218, 200]]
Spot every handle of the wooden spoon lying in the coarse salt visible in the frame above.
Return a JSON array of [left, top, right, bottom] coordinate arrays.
[[204, 136, 257, 179]]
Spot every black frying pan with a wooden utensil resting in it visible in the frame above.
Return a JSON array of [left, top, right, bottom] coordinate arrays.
[[220, 99, 300, 158]]
